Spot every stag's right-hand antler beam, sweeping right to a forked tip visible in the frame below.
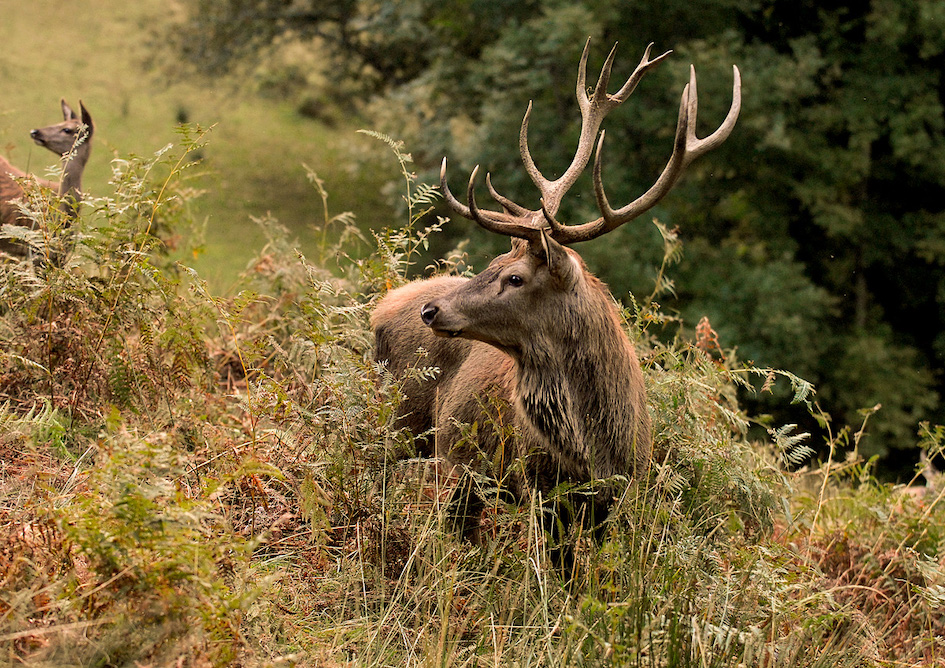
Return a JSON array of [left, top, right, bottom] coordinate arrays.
[[555, 66, 741, 244]]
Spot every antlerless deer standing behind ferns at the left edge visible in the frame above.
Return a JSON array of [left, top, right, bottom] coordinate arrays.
[[0, 100, 94, 263]]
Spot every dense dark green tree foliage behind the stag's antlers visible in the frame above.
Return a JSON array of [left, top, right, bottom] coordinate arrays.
[[166, 0, 945, 472]]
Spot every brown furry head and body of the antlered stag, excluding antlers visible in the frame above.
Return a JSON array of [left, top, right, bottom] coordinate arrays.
[[372, 239, 650, 532]]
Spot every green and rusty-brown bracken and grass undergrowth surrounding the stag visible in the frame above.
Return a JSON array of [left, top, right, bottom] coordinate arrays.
[[0, 128, 945, 667]]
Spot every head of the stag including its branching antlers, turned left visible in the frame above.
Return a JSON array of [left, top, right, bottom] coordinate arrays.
[[421, 40, 741, 359]]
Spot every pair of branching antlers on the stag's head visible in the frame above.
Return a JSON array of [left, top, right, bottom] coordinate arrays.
[[440, 39, 741, 244]]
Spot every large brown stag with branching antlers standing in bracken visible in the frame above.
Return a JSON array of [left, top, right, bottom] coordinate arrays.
[[372, 37, 741, 560]]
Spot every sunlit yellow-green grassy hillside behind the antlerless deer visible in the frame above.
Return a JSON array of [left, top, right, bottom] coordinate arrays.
[[0, 0, 396, 290]]
